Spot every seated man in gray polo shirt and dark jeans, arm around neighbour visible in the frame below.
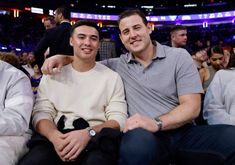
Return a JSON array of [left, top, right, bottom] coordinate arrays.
[[43, 10, 235, 165]]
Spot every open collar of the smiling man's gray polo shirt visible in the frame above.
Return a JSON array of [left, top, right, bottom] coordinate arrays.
[[127, 41, 166, 63]]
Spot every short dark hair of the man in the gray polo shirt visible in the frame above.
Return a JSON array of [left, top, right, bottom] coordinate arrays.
[[118, 9, 148, 26]]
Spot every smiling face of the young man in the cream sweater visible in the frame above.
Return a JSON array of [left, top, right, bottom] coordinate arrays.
[[70, 25, 99, 61]]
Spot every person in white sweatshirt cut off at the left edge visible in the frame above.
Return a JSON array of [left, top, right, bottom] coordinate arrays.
[[0, 58, 33, 165]]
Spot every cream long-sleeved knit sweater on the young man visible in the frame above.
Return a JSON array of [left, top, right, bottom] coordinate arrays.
[[33, 63, 127, 129]]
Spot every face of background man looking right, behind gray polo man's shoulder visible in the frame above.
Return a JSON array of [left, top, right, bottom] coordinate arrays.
[[171, 30, 188, 47]]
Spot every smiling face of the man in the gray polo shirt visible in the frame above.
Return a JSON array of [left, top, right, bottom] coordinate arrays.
[[119, 15, 151, 54]]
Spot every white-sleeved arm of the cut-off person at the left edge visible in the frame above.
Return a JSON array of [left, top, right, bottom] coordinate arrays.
[[0, 76, 33, 136]]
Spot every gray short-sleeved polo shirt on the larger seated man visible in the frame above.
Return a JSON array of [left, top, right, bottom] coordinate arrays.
[[102, 42, 203, 118]]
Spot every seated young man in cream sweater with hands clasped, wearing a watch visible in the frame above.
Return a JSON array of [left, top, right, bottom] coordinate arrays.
[[21, 21, 127, 165]]
